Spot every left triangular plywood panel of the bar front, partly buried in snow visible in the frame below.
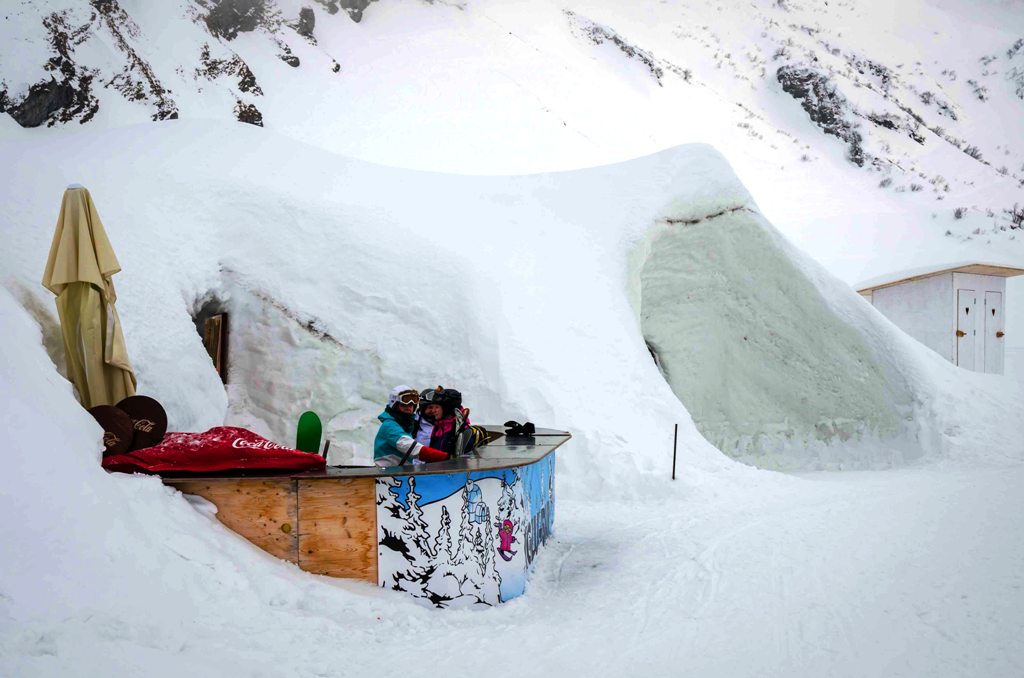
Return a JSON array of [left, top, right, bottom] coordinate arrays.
[[164, 478, 299, 563]]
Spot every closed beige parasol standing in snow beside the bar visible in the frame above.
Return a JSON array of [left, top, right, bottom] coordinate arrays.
[[43, 185, 135, 409]]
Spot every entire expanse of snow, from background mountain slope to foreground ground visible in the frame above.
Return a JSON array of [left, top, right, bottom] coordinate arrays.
[[6, 0, 1024, 677]]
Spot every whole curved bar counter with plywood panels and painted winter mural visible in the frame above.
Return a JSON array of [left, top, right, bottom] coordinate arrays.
[[163, 429, 570, 607]]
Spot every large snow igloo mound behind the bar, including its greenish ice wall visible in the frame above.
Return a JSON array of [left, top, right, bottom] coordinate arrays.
[[0, 122, 1015, 483]]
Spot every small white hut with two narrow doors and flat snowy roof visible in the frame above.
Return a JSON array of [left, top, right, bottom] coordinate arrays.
[[857, 263, 1024, 374]]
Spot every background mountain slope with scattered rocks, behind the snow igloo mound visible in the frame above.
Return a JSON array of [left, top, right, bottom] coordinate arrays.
[[0, 0, 1024, 364]]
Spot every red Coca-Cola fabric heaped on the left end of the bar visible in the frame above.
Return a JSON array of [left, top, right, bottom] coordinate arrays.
[[103, 426, 327, 473]]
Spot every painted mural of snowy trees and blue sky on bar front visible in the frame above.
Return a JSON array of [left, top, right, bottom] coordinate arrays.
[[377, 454, 555, 607]]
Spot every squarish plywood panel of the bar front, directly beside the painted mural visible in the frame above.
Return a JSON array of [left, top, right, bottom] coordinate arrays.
[[297, 478, 377, 584]]
